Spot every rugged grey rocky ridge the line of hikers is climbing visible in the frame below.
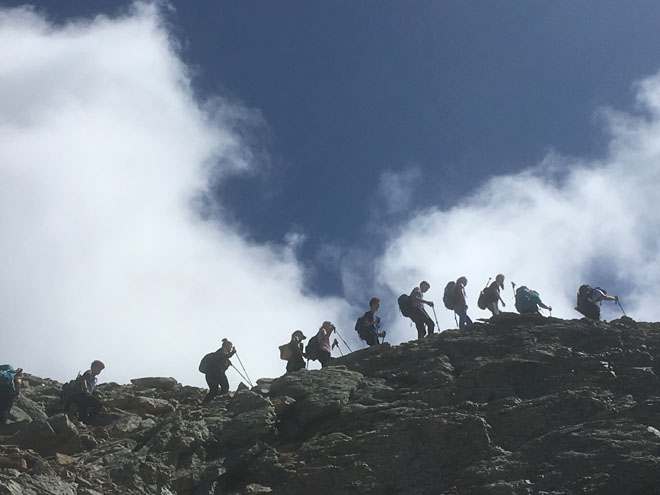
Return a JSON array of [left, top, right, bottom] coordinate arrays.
[[0, 314, 660, 495]]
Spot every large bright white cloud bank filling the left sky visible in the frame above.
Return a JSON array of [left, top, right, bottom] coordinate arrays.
[[0, 5, 346, 386]]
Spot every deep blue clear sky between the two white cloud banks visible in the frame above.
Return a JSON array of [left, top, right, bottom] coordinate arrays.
[[3, 0, 660, 294]]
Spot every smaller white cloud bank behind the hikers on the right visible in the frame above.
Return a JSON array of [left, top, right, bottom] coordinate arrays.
[[376, 76, 660, 339]]
